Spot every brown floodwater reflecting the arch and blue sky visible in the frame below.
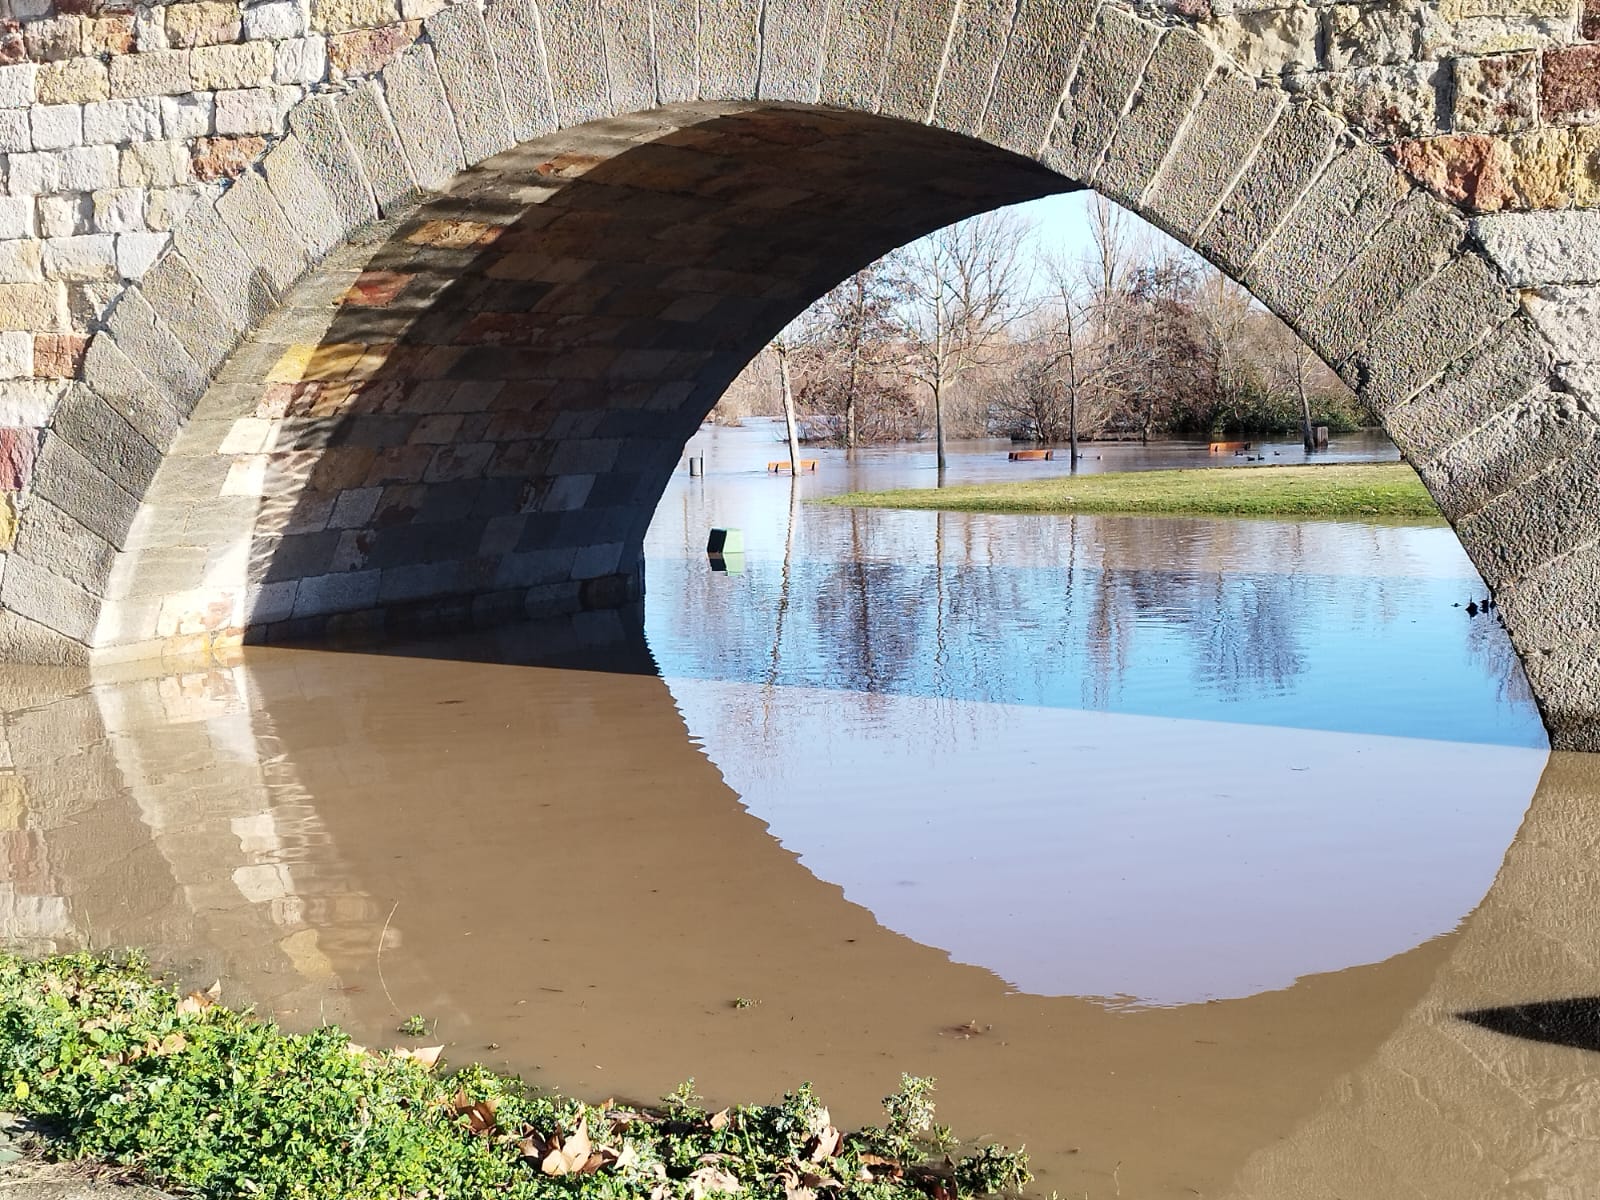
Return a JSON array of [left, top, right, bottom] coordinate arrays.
[[0, 424, 1600, 1200]]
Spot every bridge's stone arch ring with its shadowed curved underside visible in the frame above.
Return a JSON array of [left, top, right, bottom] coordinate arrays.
[[9, 0, 1600, 747]]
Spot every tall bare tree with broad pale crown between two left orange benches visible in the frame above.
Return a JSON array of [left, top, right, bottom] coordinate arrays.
[[901, 211, 1030, 470]]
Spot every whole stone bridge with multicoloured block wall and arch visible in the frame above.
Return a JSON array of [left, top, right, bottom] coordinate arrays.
[[0, 0, 1600, 749]]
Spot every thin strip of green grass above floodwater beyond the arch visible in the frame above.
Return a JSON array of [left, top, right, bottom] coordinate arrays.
[[814, 462, 1440, 520]]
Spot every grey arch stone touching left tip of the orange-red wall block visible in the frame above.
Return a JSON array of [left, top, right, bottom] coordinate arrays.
[[1245, 147, 1405, 323]]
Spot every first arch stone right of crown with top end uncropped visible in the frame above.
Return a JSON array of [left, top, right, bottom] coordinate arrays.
[[1045, 6, 1162, 184]]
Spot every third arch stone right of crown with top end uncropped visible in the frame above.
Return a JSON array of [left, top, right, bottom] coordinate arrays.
[[1146, 72, 1283, 243]]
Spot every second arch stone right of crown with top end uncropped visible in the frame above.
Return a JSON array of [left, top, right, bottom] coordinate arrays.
[[1094, 29, 1216, 208]]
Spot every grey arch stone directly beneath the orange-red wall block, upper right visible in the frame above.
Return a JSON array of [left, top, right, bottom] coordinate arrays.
[[1296, 195, 1466, 368]]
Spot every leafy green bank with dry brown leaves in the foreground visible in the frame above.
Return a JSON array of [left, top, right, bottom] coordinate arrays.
[[0, 955, 1029, 1200]]
